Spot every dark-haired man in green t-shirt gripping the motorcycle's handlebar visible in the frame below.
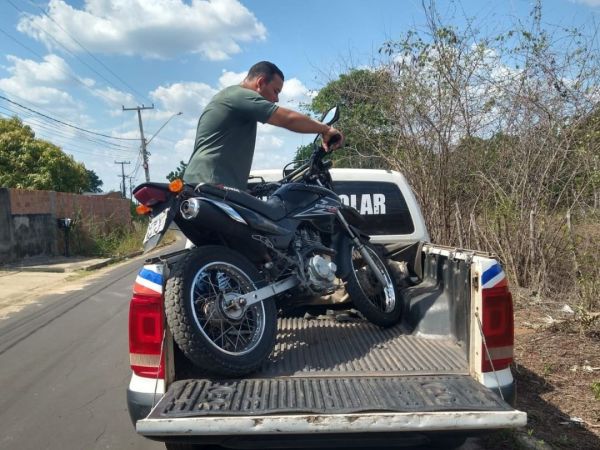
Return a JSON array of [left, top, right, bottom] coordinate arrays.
[[183, 61, 343, 190]]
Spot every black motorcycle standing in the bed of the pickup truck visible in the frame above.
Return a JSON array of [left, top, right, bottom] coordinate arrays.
[[133, 108, 402, 376]]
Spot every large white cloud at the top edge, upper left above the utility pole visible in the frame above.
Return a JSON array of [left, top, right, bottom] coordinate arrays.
[[18, 0, 267, 60]]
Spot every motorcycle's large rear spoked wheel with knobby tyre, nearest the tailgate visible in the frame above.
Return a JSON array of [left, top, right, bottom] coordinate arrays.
[[165, 246, 277, 376]]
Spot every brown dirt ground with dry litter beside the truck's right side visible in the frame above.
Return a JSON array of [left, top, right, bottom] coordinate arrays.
[[486, 294, 600, 450]]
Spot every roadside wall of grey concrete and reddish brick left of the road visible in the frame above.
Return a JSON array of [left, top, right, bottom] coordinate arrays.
[[0, 188, 131, 264]]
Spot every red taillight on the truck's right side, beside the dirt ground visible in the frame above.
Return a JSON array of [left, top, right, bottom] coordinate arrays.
[[481, 286, 514, 372]]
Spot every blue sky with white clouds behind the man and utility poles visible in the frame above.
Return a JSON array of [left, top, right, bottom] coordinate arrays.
[[0, 0, 600, 191]]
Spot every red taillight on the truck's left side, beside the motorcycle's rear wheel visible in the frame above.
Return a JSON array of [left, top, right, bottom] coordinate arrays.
[[129, 294, 165, 378]]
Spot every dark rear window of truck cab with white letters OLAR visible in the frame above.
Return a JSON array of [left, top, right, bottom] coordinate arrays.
[[333, 181, 415, 235]]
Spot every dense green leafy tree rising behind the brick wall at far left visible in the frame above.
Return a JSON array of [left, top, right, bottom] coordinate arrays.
[[0, 117, 90, 192]]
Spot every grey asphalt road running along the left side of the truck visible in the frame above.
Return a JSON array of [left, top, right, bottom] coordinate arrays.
[[0, 255, 164, 450]]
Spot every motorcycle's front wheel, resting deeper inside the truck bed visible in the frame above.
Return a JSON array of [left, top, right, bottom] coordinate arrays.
[[346, 244, 402, 327]]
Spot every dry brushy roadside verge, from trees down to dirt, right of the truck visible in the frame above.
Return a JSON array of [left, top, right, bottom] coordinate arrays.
[[296, 2, 600, 449]]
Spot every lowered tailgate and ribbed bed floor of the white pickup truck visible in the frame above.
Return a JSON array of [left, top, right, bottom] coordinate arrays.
[[137, 319, 526, 437]]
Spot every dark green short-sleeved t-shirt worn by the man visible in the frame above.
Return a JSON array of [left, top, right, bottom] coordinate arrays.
[[183, 86, 278, 190]]
